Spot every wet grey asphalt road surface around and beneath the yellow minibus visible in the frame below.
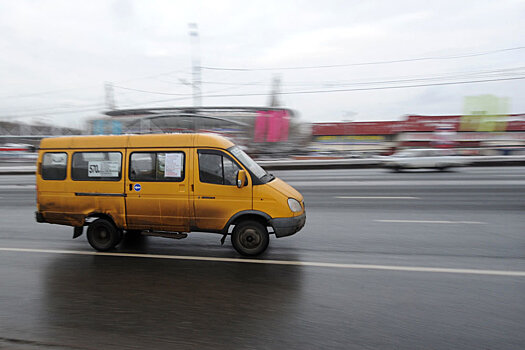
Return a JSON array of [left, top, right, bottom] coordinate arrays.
[[0, 167, 525, 350]]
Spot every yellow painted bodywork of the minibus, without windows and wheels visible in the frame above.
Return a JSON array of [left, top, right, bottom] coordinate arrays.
[[36, 134, 304, 232]]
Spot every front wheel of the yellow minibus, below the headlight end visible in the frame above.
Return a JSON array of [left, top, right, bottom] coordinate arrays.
[[231, 220, 270, 256]]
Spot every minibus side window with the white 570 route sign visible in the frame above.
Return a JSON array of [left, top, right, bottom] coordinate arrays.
[[71, 152, 122, 181]]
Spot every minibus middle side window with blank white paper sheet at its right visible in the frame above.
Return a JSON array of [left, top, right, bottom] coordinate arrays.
[[129, 152, 185, 182]]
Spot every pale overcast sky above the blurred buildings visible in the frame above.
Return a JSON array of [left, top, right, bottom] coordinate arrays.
[[0, 0, 525, 126]]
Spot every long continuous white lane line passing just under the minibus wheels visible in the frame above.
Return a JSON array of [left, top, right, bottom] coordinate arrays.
[[0, 247, 525, 277]]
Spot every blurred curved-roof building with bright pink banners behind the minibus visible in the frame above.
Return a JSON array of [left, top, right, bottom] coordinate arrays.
[[87, 107, 311, 155]]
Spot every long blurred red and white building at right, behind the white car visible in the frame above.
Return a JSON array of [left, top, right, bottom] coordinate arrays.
[[312, 114, 525, 154]]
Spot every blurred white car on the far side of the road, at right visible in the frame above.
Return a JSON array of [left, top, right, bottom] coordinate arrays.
[[383, 149, 467, 171]]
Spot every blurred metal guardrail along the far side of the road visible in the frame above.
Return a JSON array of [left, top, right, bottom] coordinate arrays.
[[0, 156, 525, 175]]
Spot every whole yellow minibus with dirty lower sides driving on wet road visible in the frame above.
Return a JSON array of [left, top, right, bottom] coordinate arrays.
[[36, 134, 306, 256]]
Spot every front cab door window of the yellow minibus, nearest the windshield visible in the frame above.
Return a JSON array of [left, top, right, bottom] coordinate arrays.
[[199, 151, 240, 186]]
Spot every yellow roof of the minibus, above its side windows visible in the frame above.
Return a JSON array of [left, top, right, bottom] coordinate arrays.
[[40, 134, 234, 149]]
